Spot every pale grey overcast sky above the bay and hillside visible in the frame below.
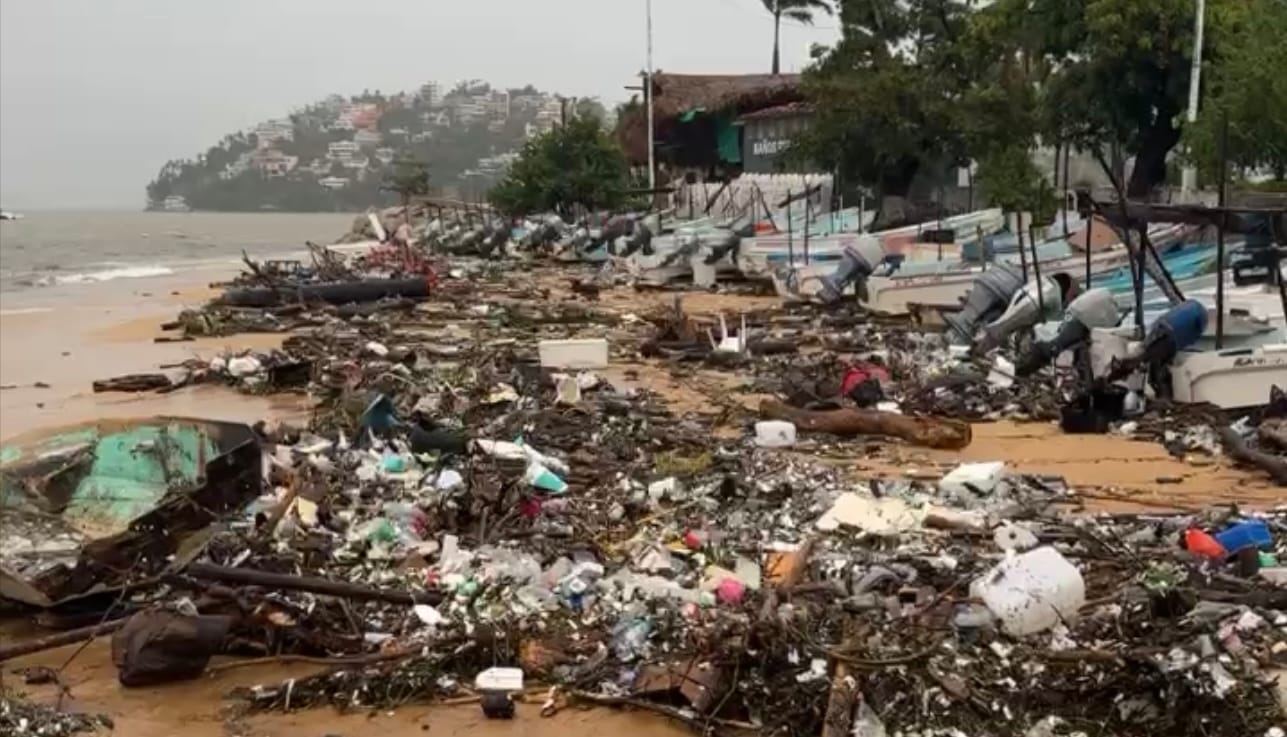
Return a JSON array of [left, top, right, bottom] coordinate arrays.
[[0, 0, 838, 210]]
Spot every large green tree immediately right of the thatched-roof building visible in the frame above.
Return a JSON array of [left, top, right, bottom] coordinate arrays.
[[792, 0, 974, 225]]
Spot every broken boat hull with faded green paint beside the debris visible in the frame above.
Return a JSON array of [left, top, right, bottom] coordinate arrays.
[[0, 417, 263, 607]]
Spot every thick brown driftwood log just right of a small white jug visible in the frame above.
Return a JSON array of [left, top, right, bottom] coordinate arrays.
[[759, 399, 972, 450]]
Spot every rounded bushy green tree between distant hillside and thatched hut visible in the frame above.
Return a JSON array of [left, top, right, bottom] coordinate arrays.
[[489, 117, 628, 215]]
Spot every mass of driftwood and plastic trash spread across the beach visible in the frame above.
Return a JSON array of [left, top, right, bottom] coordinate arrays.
[[20, 236, 1287, 737]]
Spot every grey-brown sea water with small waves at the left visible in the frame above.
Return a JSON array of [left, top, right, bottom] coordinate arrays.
[[0, 212, 355, 295]]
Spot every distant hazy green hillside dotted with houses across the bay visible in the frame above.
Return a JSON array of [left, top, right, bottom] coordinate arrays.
[[147, 80, 610, 212]]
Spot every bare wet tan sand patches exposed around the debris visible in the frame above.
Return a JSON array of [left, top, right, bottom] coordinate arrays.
[[0, 264, 1281, 737]]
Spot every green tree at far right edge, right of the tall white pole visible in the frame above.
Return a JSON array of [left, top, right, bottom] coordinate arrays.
[[1184, 0, 1287, 181]]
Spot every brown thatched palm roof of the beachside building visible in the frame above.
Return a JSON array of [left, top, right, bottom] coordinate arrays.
[[616, 73, 804, 163]]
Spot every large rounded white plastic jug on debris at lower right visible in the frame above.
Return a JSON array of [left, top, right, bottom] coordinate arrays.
[[970, 545, 1086, 637]]
